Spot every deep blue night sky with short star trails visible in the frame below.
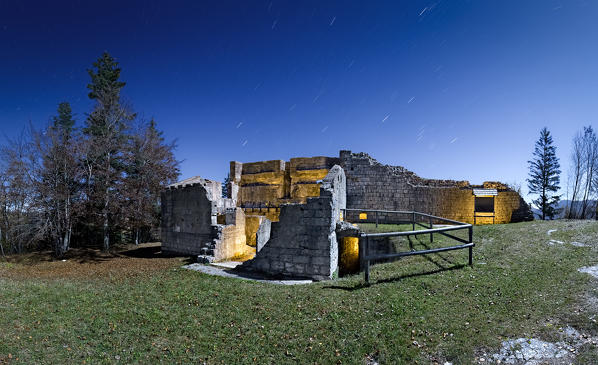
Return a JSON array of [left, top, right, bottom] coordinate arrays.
[[0, 0, 598, 199]]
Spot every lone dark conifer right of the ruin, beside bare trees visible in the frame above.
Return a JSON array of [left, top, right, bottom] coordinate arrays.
[[527, 127, 561, 220]]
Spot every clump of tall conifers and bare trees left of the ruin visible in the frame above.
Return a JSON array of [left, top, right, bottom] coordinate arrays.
[[0, 53, 179, 257]]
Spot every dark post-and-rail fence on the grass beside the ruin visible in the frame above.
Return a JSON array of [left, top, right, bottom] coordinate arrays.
[[341, 209, 475, 283]]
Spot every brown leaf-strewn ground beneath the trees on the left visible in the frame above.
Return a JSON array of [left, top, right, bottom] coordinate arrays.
[[0, 243, 187, 279]]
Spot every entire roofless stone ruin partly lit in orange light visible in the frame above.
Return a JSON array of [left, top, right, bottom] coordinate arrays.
[[161, 151, 533, 280]]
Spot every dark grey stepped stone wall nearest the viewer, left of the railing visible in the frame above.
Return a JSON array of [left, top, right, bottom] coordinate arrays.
[[242, 165, 346, 280]]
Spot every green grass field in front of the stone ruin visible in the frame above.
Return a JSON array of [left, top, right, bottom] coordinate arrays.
[[0, 221, 598, 364]]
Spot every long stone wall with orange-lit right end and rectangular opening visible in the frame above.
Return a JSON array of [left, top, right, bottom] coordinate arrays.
[[340, 151, 531, 223]]
